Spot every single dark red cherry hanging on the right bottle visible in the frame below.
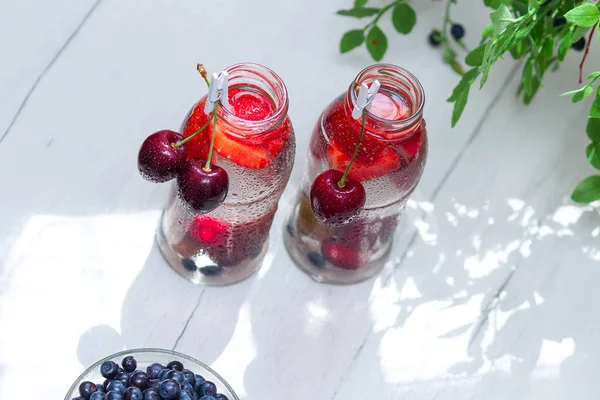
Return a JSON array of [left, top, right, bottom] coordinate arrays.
[[310, 169, 366, 226]]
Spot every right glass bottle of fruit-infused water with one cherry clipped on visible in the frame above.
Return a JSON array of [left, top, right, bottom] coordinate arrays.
[[284, 64, 427, 284]]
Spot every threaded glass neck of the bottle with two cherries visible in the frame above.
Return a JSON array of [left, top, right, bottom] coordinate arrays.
[[217, 63, 289, 137]]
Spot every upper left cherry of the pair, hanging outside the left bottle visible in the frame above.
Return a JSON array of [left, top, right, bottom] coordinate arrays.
[[138, 130, 187, 183]]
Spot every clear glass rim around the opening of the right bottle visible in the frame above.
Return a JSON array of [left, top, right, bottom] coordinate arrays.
[[349, 64, 425, 136]]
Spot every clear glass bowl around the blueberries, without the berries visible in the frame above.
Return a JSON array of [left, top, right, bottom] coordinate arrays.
[[65, 349, 239, 400]]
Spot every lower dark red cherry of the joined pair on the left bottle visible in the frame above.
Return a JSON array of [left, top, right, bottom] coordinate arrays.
[[177, 159, 229, 213]]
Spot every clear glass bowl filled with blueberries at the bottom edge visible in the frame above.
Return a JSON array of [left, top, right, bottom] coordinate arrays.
[[65, 349, 239, 400]]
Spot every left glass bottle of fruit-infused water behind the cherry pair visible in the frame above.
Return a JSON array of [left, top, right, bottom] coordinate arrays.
[[157, 64, 295, 285]]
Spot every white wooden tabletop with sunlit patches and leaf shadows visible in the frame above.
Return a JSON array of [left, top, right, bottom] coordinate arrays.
[[0, 0, 600, 400]]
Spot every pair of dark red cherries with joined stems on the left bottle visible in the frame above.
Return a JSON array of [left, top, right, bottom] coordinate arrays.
[[138, 64, 229, 213]]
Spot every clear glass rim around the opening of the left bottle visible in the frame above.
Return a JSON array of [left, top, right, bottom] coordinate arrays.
[[218, 63, 289, 134]]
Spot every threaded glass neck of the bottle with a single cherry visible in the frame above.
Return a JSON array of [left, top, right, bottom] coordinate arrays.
[[344, 64, 425, 140]]
